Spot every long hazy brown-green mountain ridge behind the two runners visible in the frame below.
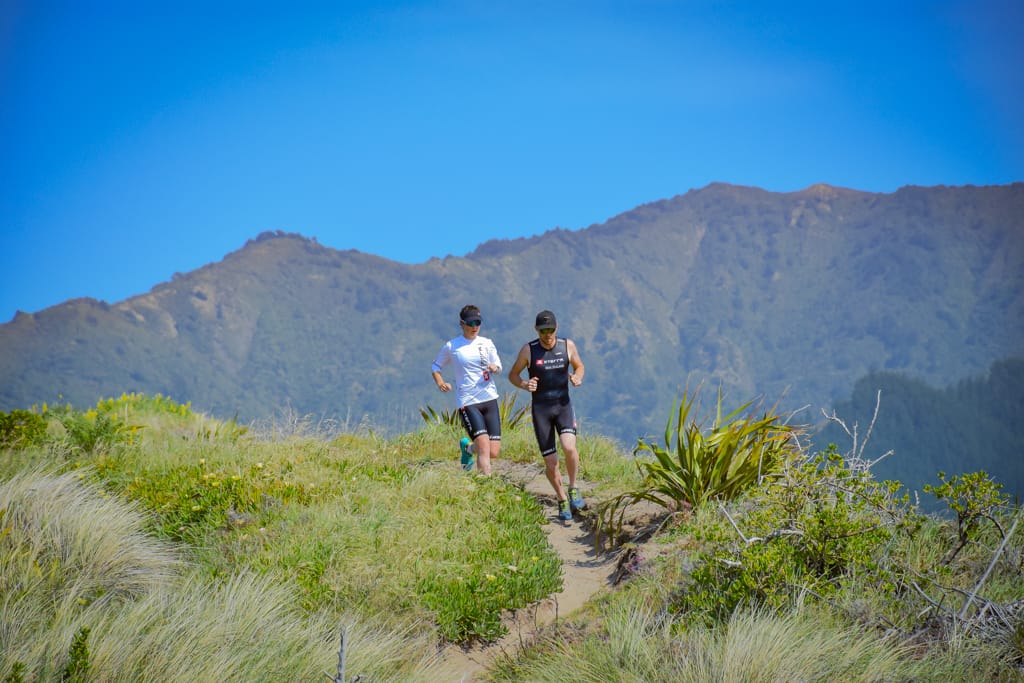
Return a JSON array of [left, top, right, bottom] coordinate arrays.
[[0, 183, 1024, 444]]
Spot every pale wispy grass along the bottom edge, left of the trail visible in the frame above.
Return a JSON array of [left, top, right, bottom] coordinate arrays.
[[91, 573, 454, 682]]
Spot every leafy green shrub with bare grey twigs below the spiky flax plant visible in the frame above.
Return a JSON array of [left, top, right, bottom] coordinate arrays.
[[675, 447, 922, 622]]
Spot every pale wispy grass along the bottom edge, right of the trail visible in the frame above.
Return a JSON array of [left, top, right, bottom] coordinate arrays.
[[488, 599, 948, 683]]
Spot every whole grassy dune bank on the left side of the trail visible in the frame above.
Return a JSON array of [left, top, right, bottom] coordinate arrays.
[[0, 396, 577, 681]]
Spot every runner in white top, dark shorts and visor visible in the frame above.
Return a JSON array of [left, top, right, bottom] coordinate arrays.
[[430, 304, 502, 474]]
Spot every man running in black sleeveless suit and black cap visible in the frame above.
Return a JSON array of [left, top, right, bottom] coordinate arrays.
[[509, 310, 586, 520]]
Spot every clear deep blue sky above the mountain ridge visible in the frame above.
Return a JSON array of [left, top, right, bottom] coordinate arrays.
[[0, 0, 1024, 322]]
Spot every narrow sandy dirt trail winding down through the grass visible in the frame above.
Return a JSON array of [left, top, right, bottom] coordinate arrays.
[[443, 462, 616, 683]]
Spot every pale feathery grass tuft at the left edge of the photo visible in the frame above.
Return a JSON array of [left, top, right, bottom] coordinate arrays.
[[0, 470, 180, 659]]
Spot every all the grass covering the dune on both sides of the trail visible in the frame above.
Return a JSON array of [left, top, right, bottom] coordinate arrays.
[[0, 396, 1024, 683]]
